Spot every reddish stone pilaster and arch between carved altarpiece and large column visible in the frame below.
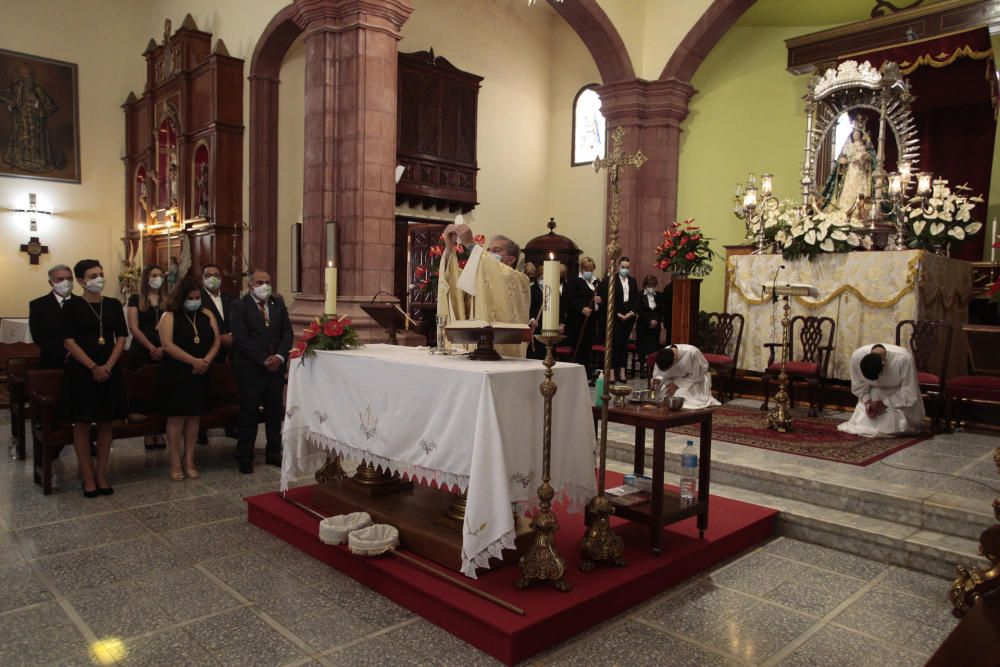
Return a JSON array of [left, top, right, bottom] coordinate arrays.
[[248, 4, 302, 279]]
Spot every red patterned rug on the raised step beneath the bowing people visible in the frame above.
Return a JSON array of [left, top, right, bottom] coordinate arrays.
[[656, 406, 931, 466]]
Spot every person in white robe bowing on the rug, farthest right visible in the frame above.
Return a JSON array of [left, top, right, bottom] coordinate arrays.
[[837, 344, 924, 437]]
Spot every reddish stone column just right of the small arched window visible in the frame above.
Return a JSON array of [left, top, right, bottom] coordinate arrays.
[[598, 79, 695, 274]]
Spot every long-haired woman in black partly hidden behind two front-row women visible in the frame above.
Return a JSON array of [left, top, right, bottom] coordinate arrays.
[[126, 264, 168, 449]]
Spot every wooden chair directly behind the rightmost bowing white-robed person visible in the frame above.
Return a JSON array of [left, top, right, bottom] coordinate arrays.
[[896, 320, 953, 432]]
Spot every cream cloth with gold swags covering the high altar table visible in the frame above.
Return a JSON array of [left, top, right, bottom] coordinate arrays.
[[726, 250, 972, 380]]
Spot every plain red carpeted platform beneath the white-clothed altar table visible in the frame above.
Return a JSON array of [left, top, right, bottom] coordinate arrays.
[[247, 472, 777, 665]]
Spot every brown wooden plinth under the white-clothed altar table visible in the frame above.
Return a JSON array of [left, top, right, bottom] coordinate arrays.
[[306, 479, 532, 572]]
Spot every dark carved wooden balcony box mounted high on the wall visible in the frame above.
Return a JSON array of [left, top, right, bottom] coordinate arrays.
[[396, 50, 483, 213]]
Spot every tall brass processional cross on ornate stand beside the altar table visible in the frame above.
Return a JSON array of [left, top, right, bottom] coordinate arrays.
[[580, 126, 646, 572]]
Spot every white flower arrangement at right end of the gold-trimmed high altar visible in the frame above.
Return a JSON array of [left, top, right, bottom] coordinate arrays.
[[901, 179, 983, 250]]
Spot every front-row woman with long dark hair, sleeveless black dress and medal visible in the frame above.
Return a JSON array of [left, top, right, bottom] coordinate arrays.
[[156, 276, 221, 482]]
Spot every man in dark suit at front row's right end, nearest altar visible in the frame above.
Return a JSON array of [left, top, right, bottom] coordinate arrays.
[[229, 269, 292, 474]]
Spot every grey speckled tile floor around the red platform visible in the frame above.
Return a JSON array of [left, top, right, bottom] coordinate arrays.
[[0, 414, 968, 666]]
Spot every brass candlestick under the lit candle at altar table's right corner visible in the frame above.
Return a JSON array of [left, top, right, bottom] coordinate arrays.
[[514, 332, 572, 593]]
